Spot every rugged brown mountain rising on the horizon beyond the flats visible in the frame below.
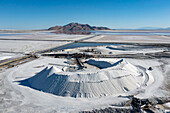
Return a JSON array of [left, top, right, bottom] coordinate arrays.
[[48, 23, 110, 34]]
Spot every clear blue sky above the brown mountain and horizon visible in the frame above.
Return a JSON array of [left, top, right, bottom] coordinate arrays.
[[0, 0, 170, 29]]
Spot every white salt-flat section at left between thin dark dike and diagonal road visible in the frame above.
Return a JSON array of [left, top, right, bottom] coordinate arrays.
[[0, 40, 67, 53]]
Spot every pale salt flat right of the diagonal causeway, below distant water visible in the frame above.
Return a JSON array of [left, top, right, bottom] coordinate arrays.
[[84, 35, 170, 44]]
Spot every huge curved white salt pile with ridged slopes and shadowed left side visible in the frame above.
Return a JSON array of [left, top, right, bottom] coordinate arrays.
[[19, 59, 142, 98]]
